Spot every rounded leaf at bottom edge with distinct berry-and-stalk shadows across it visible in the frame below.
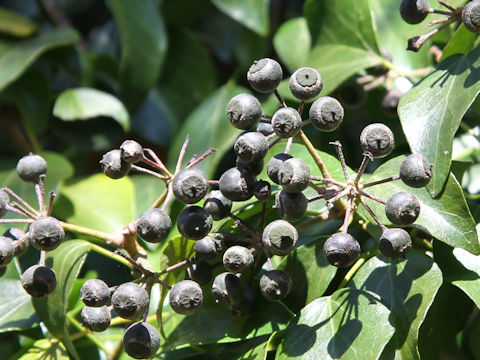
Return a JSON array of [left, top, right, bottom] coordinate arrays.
[[275, 288, 394, 360]]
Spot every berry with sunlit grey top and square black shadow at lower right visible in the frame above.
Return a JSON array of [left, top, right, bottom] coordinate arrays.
[[262, 220, 298, 255]]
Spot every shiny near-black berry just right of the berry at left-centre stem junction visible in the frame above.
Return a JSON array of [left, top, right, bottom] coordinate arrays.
[[177, 206, 213, 240]]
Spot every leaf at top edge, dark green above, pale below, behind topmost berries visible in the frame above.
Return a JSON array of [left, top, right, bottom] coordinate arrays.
[[304, 0, 382, 94]]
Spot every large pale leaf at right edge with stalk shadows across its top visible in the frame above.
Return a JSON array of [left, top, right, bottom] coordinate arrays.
[[398, 47, 480, 196]]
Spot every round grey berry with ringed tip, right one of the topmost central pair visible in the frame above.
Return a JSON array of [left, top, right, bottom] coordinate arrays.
[[290, 67, 323, 100]]
